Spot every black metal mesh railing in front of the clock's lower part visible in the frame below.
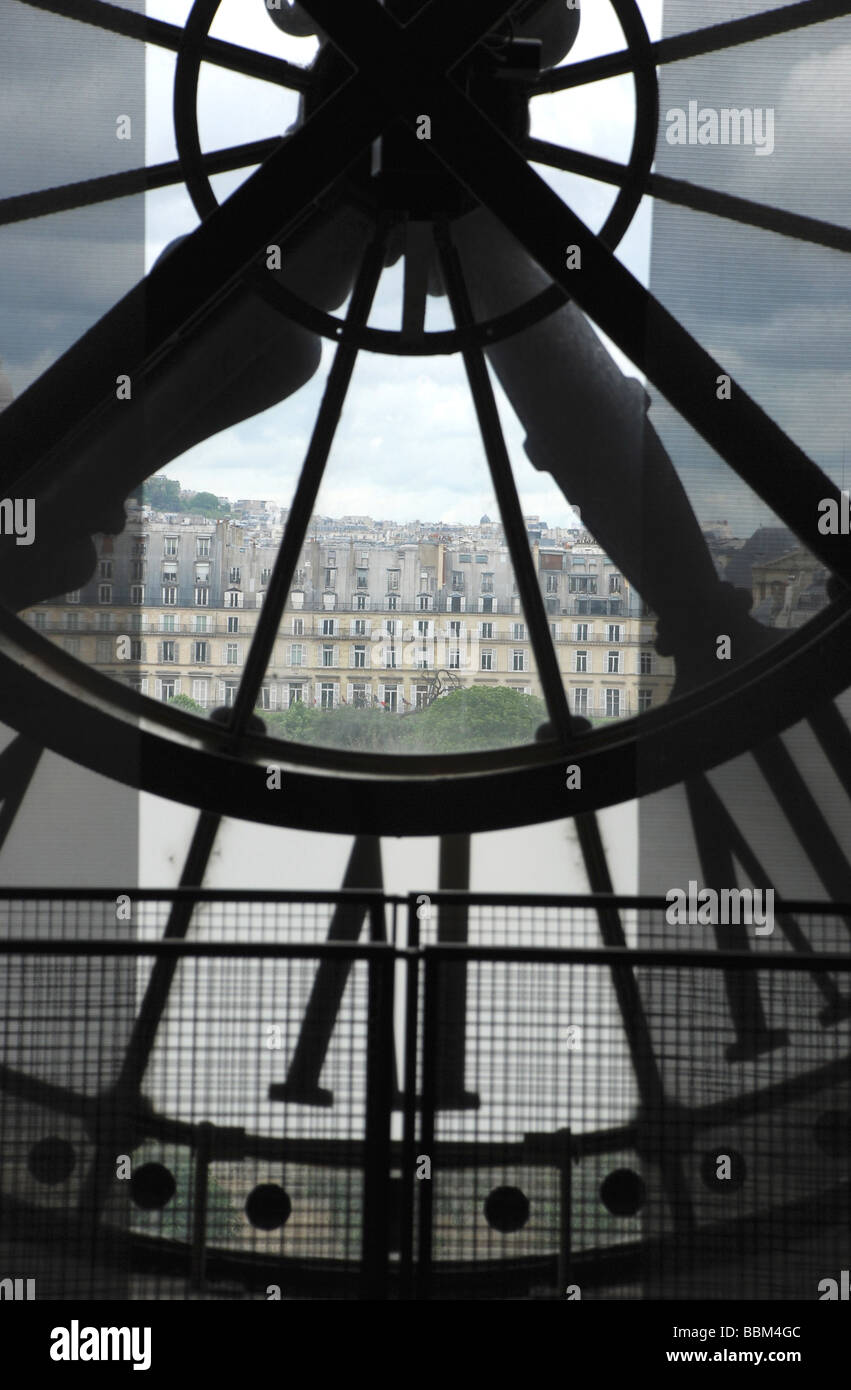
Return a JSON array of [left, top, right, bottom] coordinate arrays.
[[0, 892, 851, 1298]]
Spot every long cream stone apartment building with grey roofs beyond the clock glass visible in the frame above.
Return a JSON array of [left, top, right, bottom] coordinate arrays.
[[24, 517, 673, 720]]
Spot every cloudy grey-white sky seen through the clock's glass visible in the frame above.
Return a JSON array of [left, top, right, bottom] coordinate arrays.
[[0, 0, 851, 532]]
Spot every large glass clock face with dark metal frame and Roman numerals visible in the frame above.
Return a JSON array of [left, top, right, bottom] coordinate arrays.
[[0, 0, 851, 1298]]
